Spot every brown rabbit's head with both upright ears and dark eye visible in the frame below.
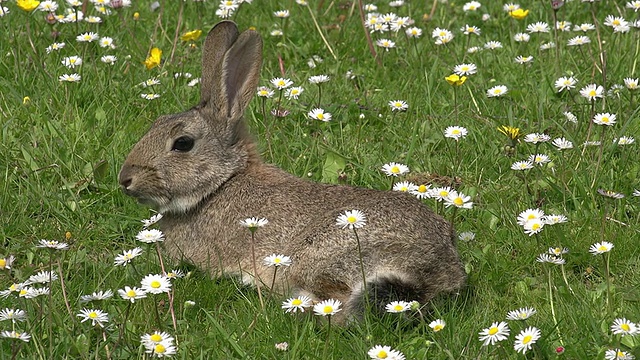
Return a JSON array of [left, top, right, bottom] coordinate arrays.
[[119, 21, 262, 213]]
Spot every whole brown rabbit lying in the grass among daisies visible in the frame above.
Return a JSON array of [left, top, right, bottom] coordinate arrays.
[[119, 21, 466, 321]]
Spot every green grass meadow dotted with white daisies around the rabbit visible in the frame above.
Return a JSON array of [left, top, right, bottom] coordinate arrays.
[[0, 0, 640, 359]]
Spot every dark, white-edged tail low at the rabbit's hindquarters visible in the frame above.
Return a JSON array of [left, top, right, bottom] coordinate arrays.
[[346, 272, 425, 316]]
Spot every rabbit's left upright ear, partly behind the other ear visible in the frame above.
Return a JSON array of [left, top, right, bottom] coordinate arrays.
[[200, 21, 239, 105]]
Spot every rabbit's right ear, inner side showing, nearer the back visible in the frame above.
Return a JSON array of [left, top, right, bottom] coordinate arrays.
[[214, 30, 262, 119]]
